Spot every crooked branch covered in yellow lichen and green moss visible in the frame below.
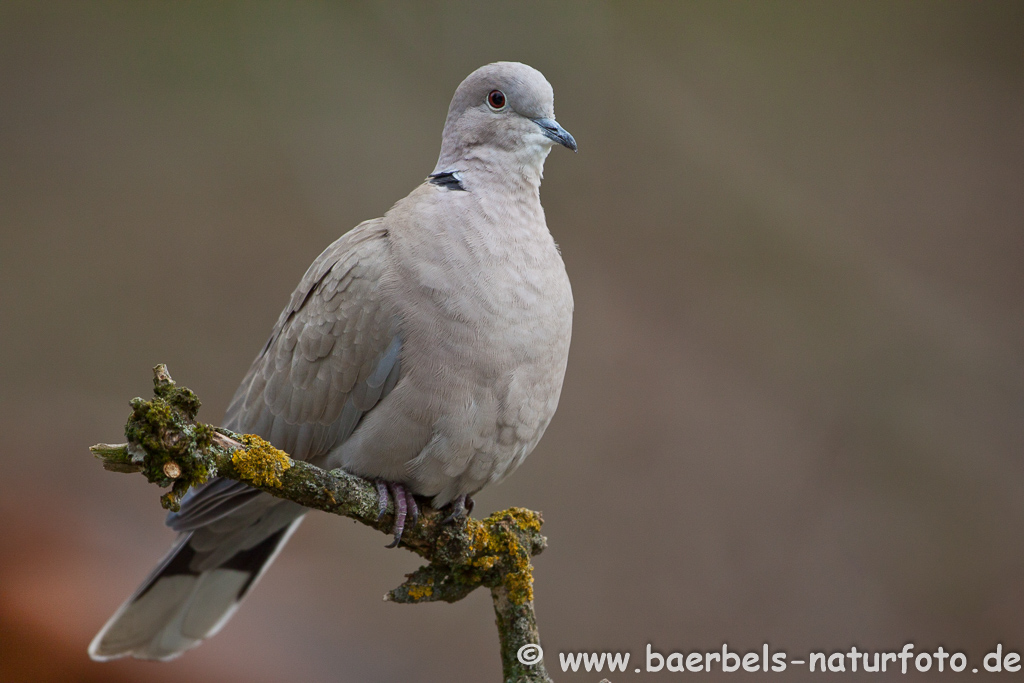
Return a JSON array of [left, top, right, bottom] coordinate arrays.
[[91, 365, 551, 683]]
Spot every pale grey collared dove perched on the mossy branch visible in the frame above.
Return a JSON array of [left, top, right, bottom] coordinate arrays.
[[89, 61, 577, 660]]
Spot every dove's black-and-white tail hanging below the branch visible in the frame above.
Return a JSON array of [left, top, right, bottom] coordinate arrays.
[[89, 517, 302, 661]]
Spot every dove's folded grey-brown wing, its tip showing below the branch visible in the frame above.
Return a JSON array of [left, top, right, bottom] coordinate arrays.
[[168, 219, 401, 530]]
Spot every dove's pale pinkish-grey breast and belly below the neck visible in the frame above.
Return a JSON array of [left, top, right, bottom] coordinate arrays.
[[356, 187, 572, 503]]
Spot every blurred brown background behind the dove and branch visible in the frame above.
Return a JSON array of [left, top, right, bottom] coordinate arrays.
[[0, 0, 1024, 683]]
